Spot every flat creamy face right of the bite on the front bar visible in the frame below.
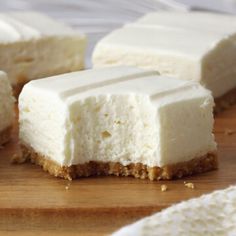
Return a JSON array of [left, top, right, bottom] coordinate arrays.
[[154, 94, 216, 166]]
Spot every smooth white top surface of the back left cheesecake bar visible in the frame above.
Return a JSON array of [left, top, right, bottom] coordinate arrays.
[[0, 12, 84, 43]]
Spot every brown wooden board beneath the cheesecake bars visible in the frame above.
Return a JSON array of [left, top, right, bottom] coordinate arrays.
[[0, 106, 236, 236]]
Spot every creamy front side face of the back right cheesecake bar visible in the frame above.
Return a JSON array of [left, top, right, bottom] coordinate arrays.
[[93, 45, 201, 81]]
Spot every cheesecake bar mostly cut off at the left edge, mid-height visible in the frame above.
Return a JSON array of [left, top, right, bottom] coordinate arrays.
[[0, 71, 15, 146]]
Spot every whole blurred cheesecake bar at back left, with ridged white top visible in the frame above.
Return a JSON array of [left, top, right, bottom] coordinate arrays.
[[0, 12, 86, 95]]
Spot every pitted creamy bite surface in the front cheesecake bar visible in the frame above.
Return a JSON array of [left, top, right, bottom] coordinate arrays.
[[69, 94, 160, 166]]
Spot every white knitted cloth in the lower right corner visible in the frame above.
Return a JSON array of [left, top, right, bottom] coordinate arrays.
[[113, 186, 236, 236]]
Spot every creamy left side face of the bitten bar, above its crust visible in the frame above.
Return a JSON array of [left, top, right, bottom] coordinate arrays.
[[19, 90, 67, 166]]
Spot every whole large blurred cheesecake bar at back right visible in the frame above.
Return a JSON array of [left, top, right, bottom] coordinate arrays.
[[93, 12, 236, 112]]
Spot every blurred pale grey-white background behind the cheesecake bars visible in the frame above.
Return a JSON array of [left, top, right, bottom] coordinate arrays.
[[0, 0, 236, 67]]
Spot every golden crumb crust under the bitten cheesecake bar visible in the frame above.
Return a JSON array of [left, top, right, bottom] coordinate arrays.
[[19, 145, 218, 180]]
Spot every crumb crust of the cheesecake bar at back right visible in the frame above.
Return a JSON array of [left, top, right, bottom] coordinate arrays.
[[214, 88, 236, 115]]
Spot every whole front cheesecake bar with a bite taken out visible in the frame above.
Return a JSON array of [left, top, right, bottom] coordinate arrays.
[[19, 67, 217, 180]]
